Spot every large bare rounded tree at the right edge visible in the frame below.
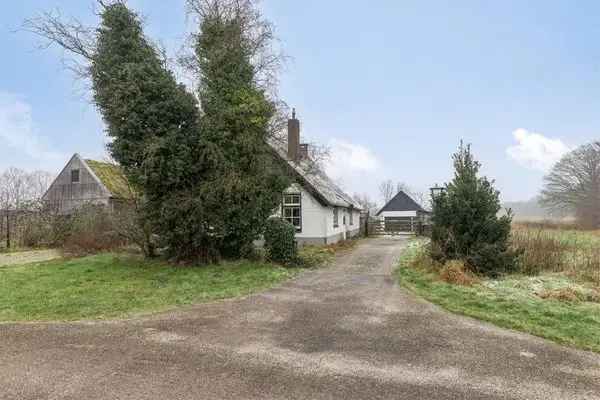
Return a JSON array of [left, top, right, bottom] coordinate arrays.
[[541, 142, 600, 228]]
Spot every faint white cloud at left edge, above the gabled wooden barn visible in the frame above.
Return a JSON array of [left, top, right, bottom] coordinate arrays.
[[0, 92, 65, 165]]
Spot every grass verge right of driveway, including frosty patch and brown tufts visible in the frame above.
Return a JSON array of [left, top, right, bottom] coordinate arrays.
[[396, 241, 600, 352]]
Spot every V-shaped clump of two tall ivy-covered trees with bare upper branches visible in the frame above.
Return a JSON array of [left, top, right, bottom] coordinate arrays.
[[26, 0, 288, 261]]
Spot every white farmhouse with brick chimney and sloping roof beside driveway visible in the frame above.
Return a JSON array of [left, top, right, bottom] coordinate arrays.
[[271, 112, 360, 245]]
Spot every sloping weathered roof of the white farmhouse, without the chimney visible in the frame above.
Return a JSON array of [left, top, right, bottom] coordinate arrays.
[[269, 140, 361, 210]]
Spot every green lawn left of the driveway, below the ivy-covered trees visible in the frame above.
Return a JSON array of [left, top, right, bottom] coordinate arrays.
[[0, 254, 296, 321]]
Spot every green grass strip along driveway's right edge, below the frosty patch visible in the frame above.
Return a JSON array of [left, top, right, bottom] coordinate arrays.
[[396, 239, 600, 352]]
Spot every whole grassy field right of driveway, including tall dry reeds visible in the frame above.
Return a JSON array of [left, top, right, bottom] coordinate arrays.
[[397, 225, 600, 352]]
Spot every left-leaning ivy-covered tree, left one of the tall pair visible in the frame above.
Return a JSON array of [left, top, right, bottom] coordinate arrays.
[[90, 2, 221, 261]]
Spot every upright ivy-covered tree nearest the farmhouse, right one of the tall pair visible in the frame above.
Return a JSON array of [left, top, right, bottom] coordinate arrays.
[[195, 2, 289, 257]]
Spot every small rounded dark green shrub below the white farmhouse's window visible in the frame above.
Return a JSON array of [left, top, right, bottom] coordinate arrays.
[[264, 218, 298, 264]]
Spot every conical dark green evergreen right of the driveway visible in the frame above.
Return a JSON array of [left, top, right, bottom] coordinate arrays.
[[432, 142, 516, 276]]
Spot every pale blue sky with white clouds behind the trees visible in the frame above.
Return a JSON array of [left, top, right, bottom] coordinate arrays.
[[0, 0, 600, 200]]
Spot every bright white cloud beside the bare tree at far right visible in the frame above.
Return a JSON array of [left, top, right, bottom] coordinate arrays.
[[506, 129, 571, 172]]
